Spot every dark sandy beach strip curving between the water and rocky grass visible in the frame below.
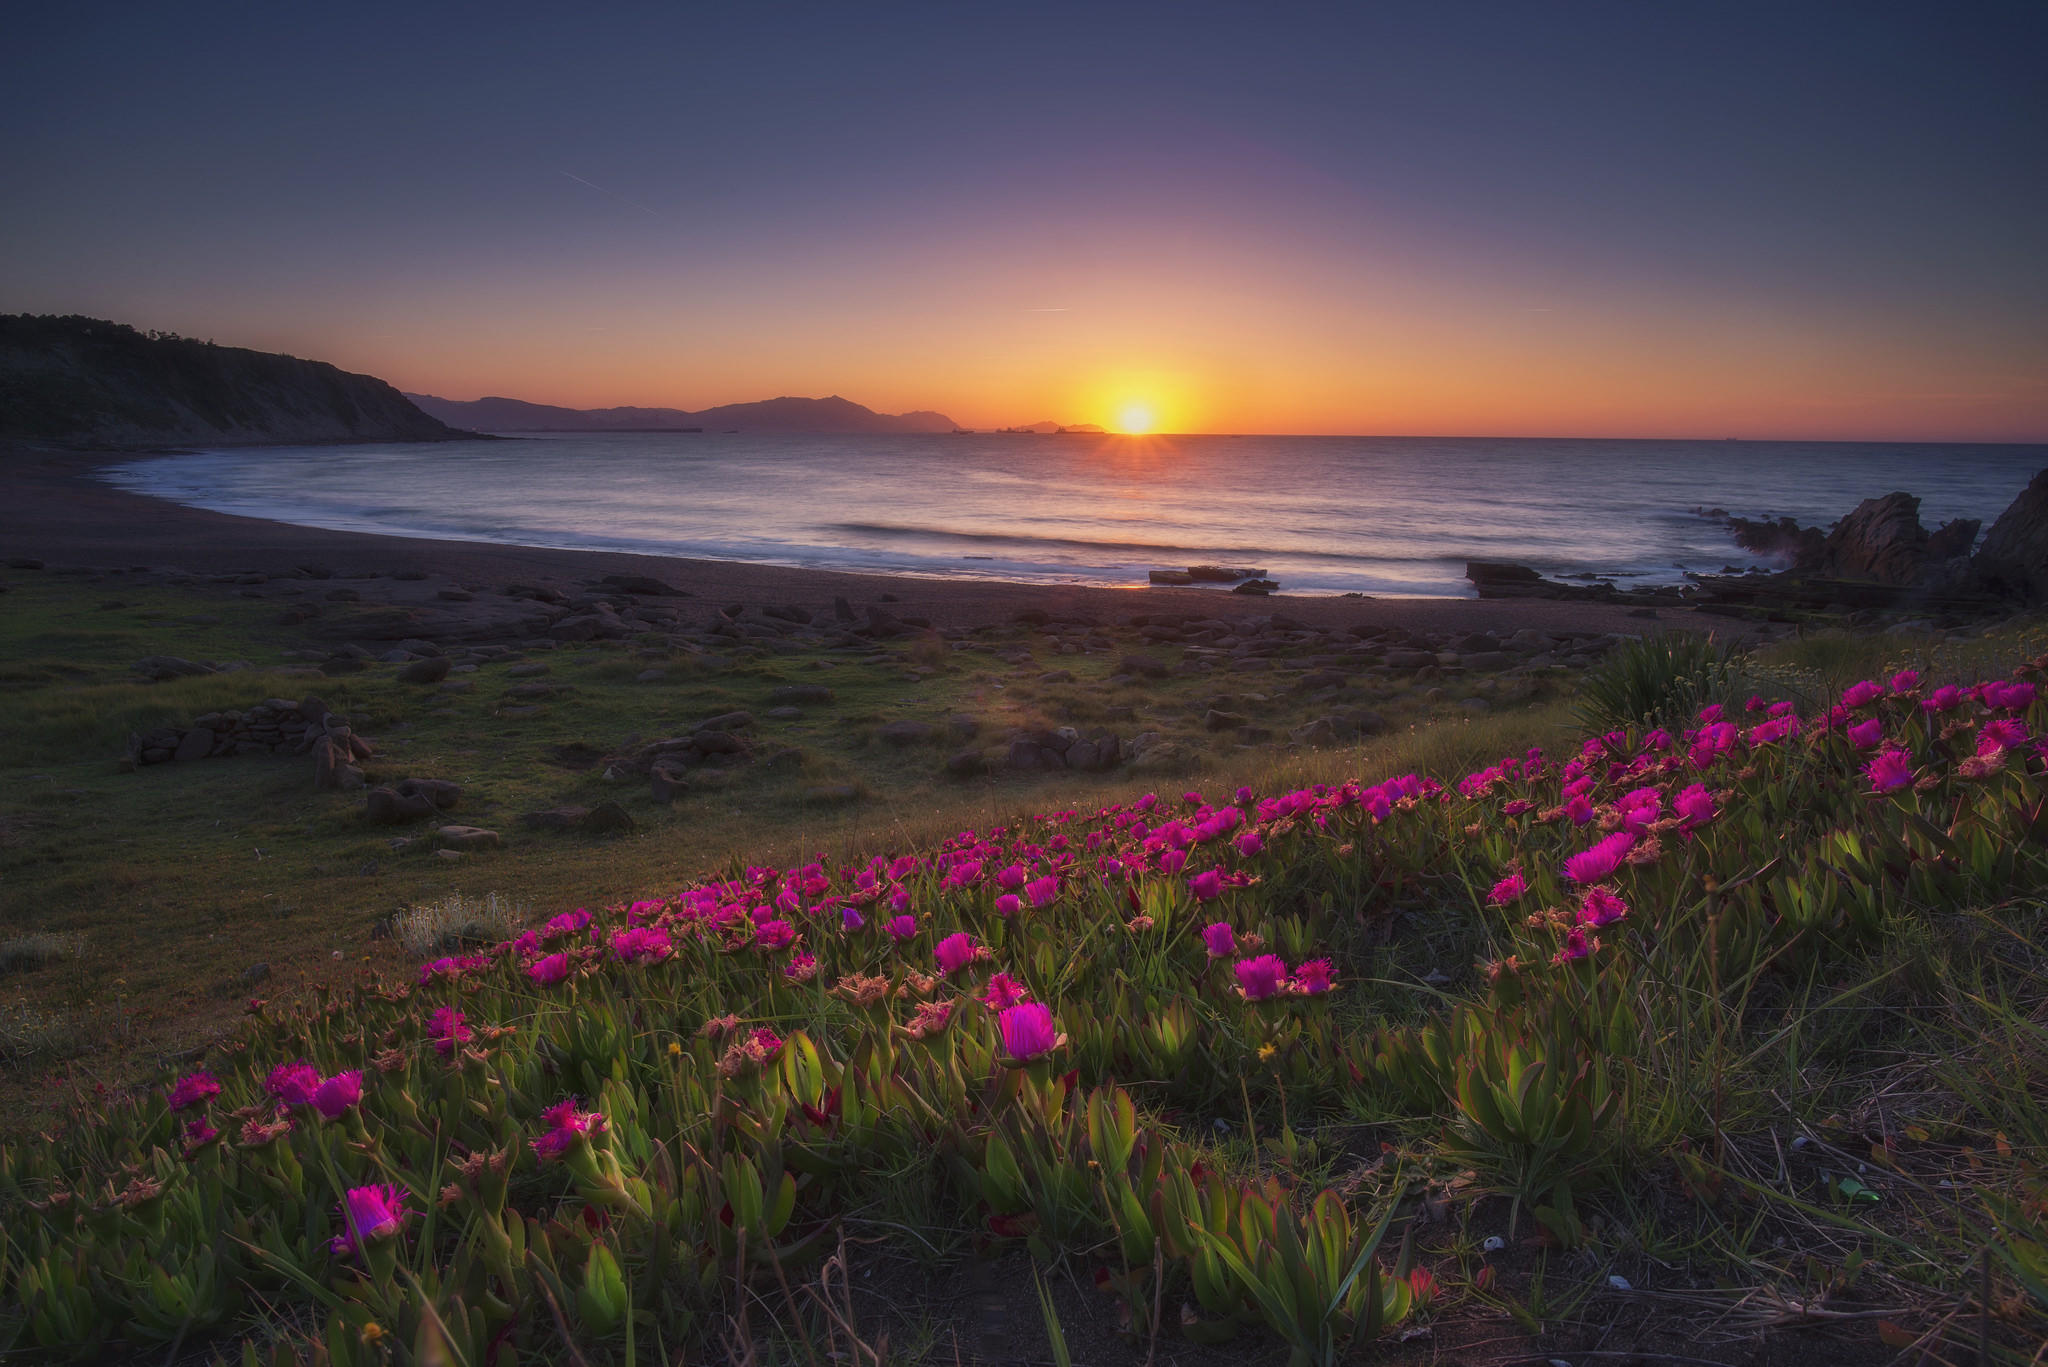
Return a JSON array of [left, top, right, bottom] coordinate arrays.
[[0, 441, 1757, 639]]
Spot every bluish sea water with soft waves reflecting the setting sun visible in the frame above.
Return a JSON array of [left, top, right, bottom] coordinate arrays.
[[104, 432, 2048, 596]]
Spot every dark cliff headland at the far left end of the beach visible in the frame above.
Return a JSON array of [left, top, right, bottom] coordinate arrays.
[[0, 314, 467, 447]]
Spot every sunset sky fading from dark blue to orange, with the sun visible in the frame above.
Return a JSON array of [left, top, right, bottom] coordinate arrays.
[[0, 0, 2048, 441]]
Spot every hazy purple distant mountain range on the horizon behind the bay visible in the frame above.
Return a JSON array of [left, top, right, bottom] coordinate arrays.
[[406, 393, 956, 432]]
